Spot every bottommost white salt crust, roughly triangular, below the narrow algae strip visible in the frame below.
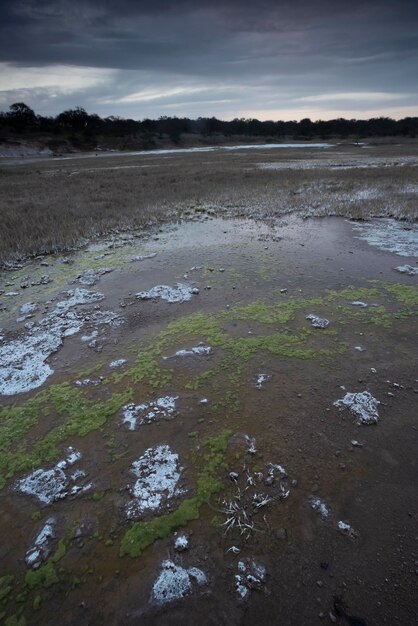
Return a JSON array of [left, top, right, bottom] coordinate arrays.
[[151, 560, 207, 605]]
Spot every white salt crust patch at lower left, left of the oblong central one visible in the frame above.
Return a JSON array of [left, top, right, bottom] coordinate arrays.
[[15, 448, 92, 504]]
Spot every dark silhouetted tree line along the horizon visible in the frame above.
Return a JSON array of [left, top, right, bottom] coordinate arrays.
[[0, 102, 418, 147]]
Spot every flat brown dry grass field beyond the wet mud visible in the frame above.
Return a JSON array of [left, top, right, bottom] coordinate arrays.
[[0, 144, 418, 263]]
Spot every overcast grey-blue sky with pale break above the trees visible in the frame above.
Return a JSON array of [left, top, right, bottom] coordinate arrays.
[[0, 0, 418, 121]]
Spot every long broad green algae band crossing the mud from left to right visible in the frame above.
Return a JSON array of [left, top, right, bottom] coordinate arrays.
[[0, 281, 418, 489]]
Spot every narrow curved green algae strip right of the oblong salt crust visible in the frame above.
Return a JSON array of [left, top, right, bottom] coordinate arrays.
[[120, 430, 232, 557]]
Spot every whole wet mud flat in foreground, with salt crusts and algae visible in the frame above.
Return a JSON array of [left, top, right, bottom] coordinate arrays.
[[0, 215, 418, 626]]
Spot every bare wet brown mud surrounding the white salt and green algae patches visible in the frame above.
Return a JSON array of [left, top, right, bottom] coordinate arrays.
[[0, 216, 418, 626]]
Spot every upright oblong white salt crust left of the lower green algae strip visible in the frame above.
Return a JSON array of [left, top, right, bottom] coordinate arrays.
[[126, 445, 183, 519]]
